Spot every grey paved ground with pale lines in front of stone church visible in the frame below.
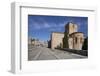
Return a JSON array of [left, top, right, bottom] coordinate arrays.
[[28, 46, 87, 61]]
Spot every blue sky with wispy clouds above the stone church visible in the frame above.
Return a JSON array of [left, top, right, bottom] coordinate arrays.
[[28, 15, 88, 41]]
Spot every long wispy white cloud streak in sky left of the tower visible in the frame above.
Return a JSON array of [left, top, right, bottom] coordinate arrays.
[[30, 18, 67, 30]]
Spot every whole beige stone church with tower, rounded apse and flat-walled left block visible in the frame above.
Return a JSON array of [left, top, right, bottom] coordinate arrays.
[[51, 22, 84, 50]]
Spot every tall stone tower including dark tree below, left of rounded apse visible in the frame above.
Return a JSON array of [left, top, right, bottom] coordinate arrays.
[[63, 22, 78, 49]]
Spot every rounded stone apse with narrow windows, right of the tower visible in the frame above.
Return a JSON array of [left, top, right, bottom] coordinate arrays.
[[68, 32, 84, 50]]
